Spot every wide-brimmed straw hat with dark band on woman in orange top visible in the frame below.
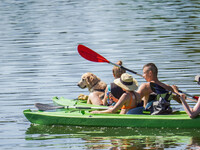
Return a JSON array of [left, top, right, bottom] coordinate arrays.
[[114, 73, 138, 91]]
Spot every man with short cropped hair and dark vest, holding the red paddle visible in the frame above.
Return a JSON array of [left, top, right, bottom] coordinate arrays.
[[137, 63, 181, 113]]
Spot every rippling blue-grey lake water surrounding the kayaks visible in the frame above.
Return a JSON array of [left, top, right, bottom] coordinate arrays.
[[0, 0, 200, 150]]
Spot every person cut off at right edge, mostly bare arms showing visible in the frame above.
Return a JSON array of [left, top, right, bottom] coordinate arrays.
[[172, 75, 200, 119]]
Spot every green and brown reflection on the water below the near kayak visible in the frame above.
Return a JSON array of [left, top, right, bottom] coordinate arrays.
[[26, 125, 200, 150]]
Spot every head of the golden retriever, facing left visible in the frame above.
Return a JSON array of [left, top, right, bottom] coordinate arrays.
[[78, 72, 100, 91]]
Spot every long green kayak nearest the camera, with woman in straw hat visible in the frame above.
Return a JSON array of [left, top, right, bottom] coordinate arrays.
[[23, 109, 200, 128]]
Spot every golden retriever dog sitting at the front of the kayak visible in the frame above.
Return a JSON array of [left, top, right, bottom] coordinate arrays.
[[78, 72, 107, 105]]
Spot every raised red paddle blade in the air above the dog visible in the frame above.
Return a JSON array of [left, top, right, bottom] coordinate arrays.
[[77, 44, 109, 63]]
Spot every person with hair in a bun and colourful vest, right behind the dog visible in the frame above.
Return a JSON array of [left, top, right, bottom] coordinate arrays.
[[102, 61, 126, 106]]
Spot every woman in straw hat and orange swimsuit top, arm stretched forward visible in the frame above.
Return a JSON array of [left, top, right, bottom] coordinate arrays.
[[92, 73, 141, 114]]
